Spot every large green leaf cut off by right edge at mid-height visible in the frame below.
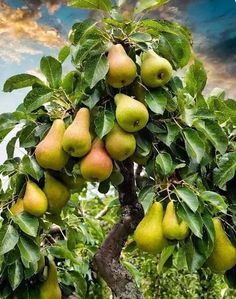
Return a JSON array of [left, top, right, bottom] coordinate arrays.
[[213, 152, 236, 189]]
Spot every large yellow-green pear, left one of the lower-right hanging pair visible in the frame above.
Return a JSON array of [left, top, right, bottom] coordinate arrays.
[[134, 202, 167, 254]]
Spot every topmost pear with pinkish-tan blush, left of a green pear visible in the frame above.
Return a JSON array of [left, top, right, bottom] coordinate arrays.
[[107, 44, 137, 88]]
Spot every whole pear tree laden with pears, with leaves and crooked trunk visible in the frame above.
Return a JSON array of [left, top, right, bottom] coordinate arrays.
[[0, 0, 236, 299]]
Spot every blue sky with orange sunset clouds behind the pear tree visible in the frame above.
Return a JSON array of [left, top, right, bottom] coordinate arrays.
[[0, 0, 236, 113]]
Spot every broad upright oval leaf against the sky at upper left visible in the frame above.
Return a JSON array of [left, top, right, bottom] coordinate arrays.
[[40, 56, 62, 89]]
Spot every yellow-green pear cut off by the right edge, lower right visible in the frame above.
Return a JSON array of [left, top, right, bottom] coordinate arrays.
[[206, 218, 236, 273]]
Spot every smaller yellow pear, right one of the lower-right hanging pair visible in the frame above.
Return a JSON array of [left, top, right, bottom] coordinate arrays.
[[162, 201, 189, 240]]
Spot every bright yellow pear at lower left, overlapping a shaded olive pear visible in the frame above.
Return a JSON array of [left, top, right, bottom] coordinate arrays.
[[23, 181, 48, 217]]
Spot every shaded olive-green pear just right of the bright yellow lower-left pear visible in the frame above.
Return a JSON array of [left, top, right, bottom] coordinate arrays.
[[43, 172, 70, 214]]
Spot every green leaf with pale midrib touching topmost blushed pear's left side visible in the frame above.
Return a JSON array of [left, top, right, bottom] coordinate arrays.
[[84, 54, 109, 89]]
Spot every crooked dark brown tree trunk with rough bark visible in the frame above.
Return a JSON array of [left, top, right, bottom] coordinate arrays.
[[92, 160, 144, 299]]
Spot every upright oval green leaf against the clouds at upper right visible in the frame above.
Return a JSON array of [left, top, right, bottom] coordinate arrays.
[[185, 60, 207, 97]]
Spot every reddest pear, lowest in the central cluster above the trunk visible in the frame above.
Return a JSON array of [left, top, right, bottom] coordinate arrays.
[[80, 138, 113, 182]]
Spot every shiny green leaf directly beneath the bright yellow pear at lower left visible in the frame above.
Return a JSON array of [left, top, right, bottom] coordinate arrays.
[[13, 212, 39, 237]]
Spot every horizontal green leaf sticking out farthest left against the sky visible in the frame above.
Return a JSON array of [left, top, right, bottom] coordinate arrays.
[[3, 74, 44, 92]]
